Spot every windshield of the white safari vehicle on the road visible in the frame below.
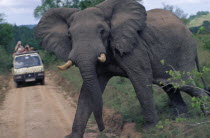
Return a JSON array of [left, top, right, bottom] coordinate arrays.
[[14, 55, 41, 69]]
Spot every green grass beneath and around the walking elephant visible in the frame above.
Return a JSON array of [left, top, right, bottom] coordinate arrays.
[[48, 35, 210, 138]]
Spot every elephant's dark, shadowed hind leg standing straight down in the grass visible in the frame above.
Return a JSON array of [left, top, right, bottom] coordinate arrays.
[[162, 84, 187, 116]]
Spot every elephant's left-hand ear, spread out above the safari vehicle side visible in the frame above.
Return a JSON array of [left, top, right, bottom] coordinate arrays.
[[35, 8, 78, 60]]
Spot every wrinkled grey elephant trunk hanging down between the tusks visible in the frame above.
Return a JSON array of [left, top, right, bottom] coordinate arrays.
[[78, 55, 105, 131]]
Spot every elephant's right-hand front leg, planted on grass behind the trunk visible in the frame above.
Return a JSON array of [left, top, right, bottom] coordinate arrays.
[[116, 51, 157, 126]]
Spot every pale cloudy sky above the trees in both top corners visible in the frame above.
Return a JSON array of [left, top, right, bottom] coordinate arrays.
[[0, 0, 210, 25]]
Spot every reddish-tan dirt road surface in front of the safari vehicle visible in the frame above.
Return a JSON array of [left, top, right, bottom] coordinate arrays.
[[0, 75, 79, 138]]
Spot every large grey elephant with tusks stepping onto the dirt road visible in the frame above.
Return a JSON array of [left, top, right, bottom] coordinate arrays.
[[35, 0, 207, 138]]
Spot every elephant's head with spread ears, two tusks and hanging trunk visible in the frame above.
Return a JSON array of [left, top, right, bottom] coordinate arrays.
[[35, 0, 146, 133]]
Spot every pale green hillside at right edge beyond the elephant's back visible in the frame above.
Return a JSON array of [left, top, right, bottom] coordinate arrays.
[[187, 14, 210, 28]]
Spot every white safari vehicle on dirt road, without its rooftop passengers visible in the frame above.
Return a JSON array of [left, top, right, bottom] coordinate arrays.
[[12, 52, 45, 87]]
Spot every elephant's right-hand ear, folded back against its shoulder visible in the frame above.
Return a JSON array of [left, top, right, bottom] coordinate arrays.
[[96, 0, 147, 55]]
